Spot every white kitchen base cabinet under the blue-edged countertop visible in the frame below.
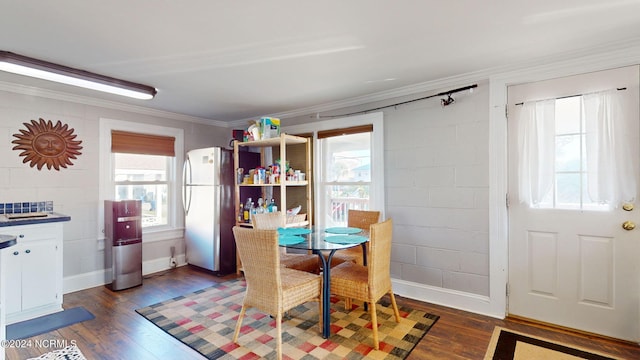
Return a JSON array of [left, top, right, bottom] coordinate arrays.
[[0, 222, 63, 324]]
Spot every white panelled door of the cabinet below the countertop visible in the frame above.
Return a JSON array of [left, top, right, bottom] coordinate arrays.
[[20, 240, 61, 310]]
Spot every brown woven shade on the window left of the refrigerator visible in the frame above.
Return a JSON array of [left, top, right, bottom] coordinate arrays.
[[111, 130, 176, 156]]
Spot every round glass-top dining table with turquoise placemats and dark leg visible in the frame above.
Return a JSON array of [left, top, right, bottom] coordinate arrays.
[[278, 227, 369, 339]]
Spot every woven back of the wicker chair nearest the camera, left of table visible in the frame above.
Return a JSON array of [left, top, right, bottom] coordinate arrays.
[[233, 226, 282, 314]]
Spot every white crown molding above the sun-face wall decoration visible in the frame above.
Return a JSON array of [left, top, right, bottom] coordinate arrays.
[[0, 81, 228, 127]]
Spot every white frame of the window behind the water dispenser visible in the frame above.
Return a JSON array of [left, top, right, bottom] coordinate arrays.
[[97, 118, 184, 243]]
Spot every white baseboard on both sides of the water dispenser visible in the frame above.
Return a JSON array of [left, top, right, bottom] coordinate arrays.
[[62, 254, 186, 294]]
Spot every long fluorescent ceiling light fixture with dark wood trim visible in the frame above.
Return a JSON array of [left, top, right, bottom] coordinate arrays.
[[0, 51, 157, 100]]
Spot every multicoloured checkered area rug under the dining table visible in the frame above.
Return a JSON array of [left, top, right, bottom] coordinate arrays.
[[136, 279, 439, 360]]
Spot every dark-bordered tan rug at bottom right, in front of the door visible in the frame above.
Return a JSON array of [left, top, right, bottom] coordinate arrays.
[[484, 326, 615, 360]]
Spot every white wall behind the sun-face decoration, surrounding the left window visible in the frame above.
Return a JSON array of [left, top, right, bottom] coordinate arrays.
[[0, 91, 231, 292]]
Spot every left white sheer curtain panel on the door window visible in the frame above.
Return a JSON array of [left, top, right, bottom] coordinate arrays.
[[518, 100, 556, 207]]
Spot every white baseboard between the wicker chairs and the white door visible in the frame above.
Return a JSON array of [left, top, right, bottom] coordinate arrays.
[[391, 279, 505, 319]]
